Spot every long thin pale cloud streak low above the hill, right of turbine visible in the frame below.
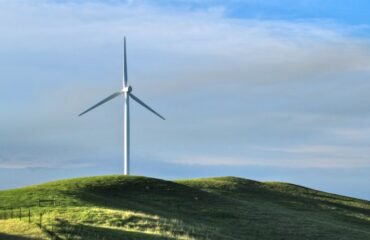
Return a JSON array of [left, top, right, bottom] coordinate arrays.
[[171, 150, 370, 169]]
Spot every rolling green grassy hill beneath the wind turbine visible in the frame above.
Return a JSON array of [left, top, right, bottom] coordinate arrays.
[[0, 176, 370, 240]]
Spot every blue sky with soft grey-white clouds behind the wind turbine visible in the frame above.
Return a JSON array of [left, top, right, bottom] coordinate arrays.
[[0, 0, 370, 200]]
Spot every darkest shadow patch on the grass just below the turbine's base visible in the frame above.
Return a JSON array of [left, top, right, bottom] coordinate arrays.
[[75, 178, 233, 218]]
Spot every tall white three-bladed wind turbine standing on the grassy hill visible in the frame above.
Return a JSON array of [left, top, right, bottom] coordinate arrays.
[[78, 37, 165, 175]]
